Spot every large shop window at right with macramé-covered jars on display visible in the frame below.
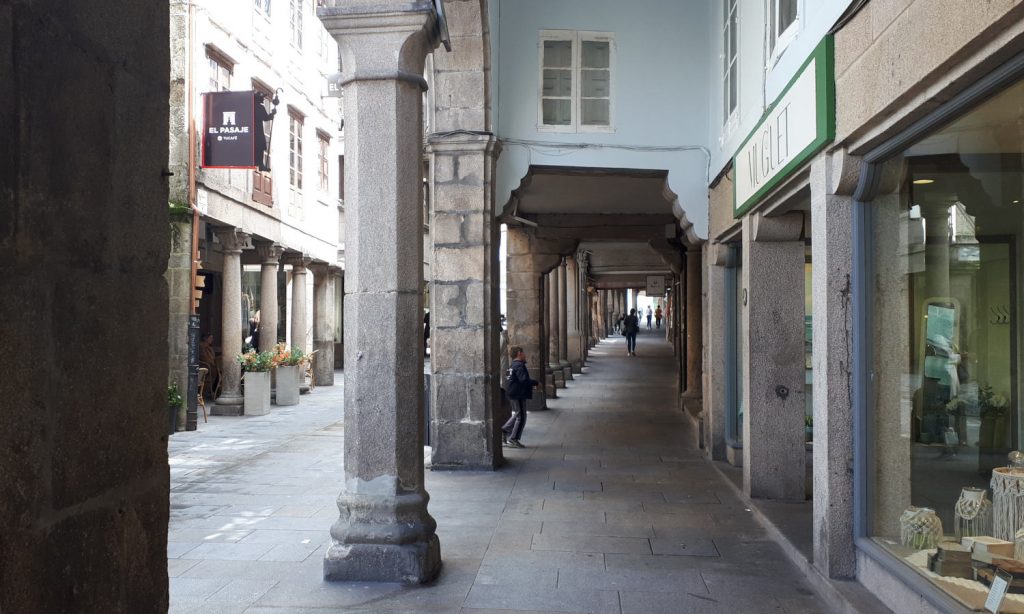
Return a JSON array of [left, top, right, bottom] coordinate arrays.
[[868, 77, 1024, 610]]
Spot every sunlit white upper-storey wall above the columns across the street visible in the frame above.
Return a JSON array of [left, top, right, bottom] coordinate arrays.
[[190, 0, 344, 263]]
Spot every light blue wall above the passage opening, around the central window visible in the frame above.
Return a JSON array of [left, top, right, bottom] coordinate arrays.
[[488, 0, 717, 236]]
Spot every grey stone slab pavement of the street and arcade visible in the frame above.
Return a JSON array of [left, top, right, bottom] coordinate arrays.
[[168, 332, 827, 614]]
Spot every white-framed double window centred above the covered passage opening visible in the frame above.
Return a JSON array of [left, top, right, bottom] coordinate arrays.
[[537, 30, 615, 132]]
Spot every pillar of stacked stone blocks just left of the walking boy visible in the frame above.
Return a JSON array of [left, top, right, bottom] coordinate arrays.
[[428, 132, 502, 470]]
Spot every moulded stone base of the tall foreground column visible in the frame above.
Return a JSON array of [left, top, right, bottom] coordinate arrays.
[[324, 492, 441, 584]]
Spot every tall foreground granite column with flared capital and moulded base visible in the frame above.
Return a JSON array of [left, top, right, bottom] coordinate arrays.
[[316, 0, 440, 583]]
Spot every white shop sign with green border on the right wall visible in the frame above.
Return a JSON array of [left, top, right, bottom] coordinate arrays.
[[732, 35, 836, 218]]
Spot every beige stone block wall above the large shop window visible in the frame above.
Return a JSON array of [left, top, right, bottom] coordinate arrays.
[[836, 0, 1024, 154]]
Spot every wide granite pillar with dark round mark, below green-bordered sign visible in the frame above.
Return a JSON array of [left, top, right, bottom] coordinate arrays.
[[745, 212, 806, 500]]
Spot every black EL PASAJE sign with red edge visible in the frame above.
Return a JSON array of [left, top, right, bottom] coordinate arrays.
[[203, 91, 254, 169]]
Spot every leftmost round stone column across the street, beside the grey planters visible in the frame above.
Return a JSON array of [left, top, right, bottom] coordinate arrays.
[[210, 228, 249, 415]]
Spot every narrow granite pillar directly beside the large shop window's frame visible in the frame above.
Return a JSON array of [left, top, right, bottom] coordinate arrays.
[[811, 151, 859, 578]]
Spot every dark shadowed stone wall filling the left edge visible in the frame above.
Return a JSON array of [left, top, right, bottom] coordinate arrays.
[[0, 0, 170, 614]]
